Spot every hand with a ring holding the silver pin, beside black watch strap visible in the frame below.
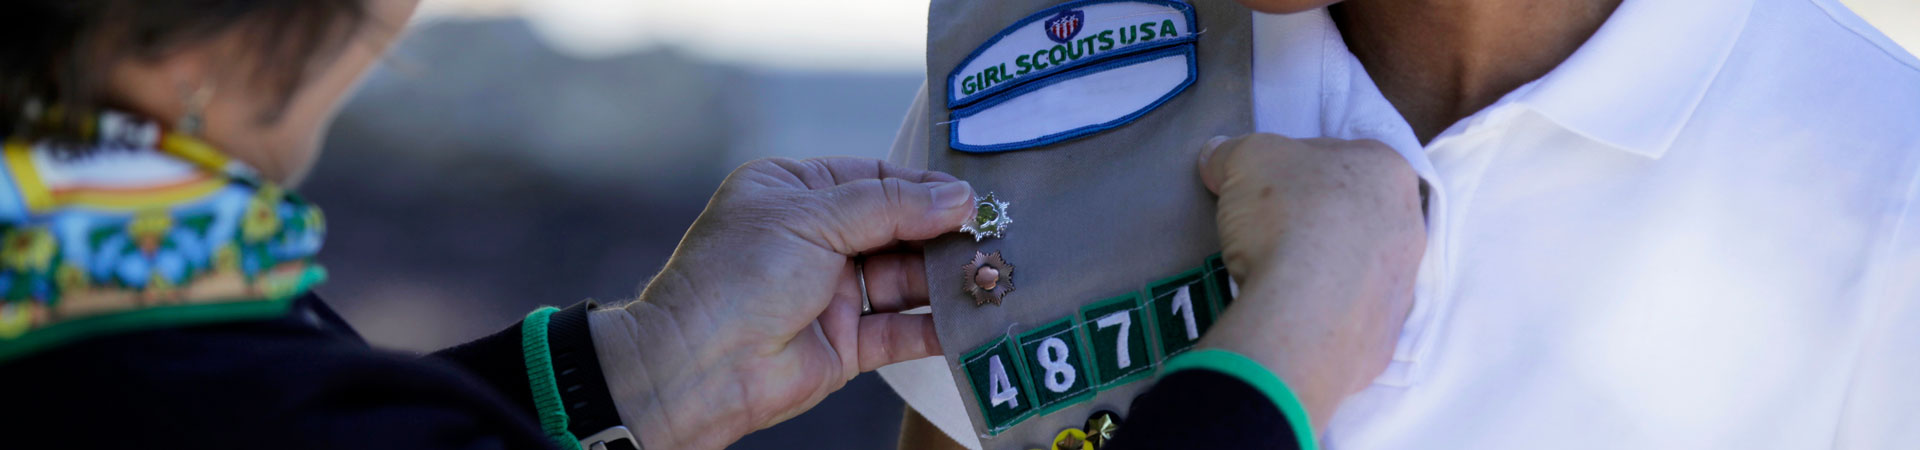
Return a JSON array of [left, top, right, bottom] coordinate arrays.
[[626, 158, 973, 448]]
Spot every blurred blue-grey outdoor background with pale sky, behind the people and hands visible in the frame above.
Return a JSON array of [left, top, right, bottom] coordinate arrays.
[[301, 0, 1920, 448]]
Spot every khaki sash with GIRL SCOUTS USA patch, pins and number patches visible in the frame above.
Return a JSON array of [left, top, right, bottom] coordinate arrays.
[[925, 0, 1252, 448]]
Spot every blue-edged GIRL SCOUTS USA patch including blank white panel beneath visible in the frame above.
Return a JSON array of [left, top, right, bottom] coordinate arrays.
[[947, 0, 1198, 152]]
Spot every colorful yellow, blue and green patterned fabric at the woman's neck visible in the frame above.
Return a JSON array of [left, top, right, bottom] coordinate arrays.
[[0, 113, 326, 362]]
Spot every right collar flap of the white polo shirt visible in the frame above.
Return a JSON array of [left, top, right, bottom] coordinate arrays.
[[1515, 0, 1753, 158]]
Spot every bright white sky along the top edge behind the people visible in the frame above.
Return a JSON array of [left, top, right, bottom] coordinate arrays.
[[420, 0, 1920, 71]]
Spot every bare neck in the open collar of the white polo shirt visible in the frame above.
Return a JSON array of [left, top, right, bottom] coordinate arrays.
[[1331, 0, 1620, 144]]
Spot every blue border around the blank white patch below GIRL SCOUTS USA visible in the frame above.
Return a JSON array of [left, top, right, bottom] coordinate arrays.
[[947, 42, 1200, 154]]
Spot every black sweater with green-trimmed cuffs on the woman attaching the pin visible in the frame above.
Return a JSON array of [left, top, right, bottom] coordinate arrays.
[[0, 296, 1292, 450]]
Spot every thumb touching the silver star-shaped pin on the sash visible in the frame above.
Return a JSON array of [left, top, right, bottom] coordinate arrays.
[[808, 179, 973, 256]]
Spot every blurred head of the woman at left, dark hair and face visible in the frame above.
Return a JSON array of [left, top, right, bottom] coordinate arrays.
[[0, 0, 419, 183]]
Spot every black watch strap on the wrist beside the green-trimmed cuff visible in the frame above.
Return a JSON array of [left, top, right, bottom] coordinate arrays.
[[547, 300, 639, 450]]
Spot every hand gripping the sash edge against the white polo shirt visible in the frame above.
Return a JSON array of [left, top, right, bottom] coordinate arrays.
[[1200, 135, 1427, 427]]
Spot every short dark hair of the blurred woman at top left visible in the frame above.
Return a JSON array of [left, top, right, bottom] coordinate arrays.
[[0, 0, 367, 140]]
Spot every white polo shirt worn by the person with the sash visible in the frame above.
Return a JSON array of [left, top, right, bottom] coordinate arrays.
[[881, 0, 1920, 448]]
